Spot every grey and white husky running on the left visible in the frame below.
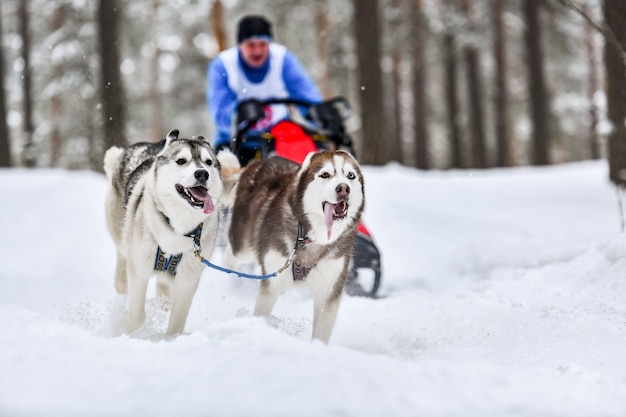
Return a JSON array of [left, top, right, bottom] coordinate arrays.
[[104, 130, 223, 335]]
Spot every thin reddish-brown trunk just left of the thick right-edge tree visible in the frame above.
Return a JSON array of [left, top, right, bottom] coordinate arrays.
[[583, 3, 600, 159]]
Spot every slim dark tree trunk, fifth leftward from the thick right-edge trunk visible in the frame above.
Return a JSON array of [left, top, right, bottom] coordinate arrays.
[[443, 32, 463, 168]]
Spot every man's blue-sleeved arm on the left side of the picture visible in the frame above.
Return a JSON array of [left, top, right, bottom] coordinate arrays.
[[207, 58, 237, 147]]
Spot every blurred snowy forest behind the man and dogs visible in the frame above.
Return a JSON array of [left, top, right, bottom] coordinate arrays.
[[0, 0, 626, 173]]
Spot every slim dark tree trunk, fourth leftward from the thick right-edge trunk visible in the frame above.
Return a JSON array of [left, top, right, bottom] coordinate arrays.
[[463, 0, 487, 168]]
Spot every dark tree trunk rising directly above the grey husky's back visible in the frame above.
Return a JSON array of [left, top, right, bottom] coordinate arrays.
[[98, 0, 128, 149]]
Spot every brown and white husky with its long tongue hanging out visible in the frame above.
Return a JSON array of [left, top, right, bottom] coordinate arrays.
[[218, 151, 365, 343]]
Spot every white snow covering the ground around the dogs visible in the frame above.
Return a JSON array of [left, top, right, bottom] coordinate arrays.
[[0, 162, 626, 417]]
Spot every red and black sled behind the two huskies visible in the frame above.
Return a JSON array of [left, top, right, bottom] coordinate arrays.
[[230, 97, 381, 298]]
